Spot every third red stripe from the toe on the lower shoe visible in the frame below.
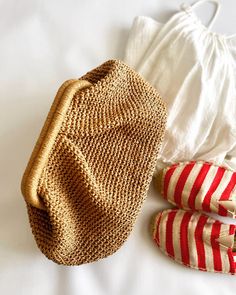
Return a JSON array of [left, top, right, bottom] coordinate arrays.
[[180, 212, 192, 265]]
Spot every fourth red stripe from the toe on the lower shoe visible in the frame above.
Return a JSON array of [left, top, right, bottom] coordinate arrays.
[[194, 215, 208, 270]]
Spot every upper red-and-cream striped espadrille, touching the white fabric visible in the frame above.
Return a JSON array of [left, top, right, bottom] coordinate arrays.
[[156, 161, 236, 218]]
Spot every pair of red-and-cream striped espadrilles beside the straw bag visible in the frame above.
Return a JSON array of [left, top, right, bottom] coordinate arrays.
[[153, 161, 236, 274]]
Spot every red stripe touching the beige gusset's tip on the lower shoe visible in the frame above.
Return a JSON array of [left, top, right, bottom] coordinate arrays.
[[211, 220, 222, 271]]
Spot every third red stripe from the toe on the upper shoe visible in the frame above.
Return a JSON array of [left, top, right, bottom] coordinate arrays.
[[188, 163, 211, 209]]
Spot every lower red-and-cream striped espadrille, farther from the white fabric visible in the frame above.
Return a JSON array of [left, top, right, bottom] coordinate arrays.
[[153, 209, 236, 274]]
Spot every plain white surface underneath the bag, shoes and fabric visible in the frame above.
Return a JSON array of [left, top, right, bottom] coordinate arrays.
[[0, 0, 236, 295]]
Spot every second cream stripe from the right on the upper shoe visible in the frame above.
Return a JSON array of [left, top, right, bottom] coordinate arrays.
[[195, 165, 218, 210]]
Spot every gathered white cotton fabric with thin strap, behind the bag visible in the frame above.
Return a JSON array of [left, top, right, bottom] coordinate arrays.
[[125, 0, 236, 175]]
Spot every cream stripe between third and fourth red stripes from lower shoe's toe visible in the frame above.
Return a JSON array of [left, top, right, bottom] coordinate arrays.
[[188, 213, 201, 267]]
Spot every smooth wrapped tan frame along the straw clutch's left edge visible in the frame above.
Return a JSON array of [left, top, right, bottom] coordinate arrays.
[[21, 80, 91, 209]]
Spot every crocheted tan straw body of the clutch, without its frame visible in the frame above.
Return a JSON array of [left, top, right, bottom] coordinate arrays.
[[21, 60, 166, 265]]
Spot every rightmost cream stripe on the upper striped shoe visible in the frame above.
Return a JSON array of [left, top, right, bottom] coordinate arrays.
[[210, 171, 232, 213]]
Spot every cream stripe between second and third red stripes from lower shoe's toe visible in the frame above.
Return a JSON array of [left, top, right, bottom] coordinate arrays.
[[172, 210, 185, 261]]
